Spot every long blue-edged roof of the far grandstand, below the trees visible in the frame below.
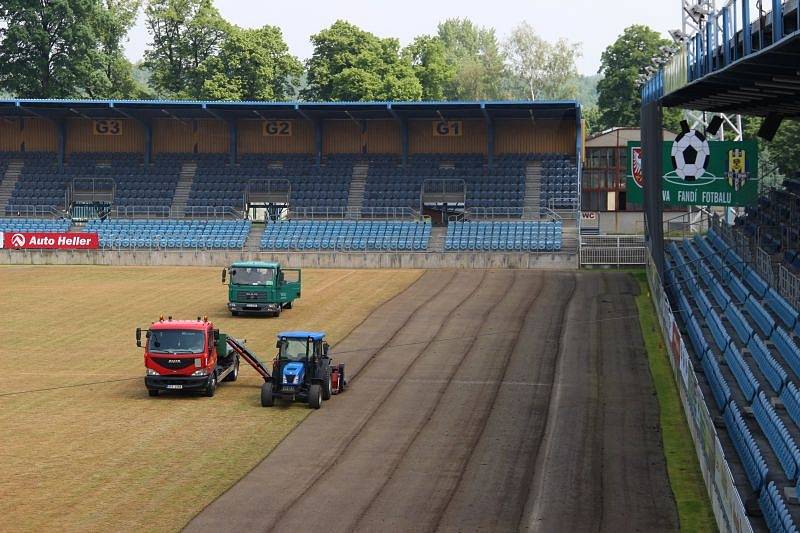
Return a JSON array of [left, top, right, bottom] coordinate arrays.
[[0, 99, 580, 120]]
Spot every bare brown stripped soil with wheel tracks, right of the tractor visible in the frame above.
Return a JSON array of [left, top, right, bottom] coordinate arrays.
[[187, 271, 678, 532]]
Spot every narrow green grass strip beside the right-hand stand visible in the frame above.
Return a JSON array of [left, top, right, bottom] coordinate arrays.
[[633, 271, 717, 532]]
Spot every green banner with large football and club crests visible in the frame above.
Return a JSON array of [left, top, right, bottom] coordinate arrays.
[[627, 135, 758, 206]]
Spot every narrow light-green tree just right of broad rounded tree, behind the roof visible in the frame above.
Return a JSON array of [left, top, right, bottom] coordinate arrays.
[[403, 35, 456, 100]]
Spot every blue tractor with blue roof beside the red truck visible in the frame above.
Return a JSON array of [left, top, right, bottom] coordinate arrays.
[[261, 331, 347, 409]]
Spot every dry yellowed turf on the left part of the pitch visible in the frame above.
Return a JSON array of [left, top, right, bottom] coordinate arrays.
[[0, 266, 421, 531]]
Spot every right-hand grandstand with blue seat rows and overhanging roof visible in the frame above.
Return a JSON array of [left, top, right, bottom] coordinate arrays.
[[642, 1, 800, 532]]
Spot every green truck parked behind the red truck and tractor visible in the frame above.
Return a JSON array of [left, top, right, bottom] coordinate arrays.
[[222, 261, 301, 316]]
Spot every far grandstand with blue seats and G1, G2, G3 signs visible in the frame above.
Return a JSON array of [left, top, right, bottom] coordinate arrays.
[[0, 100, 583, 262]]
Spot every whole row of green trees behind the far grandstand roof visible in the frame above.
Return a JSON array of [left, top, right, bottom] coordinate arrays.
[[0, 0, 580, 101]]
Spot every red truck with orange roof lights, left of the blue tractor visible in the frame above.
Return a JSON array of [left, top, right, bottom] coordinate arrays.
[[136, 317, 239, 396]]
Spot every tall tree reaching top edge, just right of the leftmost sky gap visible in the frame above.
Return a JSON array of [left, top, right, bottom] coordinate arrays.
[[144, 0, 230, 98]]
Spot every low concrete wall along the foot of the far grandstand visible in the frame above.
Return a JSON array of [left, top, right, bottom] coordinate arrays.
[[0, 250, 578, 270]]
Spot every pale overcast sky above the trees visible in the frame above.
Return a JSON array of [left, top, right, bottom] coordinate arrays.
[[127, 0, 681, 75]]
